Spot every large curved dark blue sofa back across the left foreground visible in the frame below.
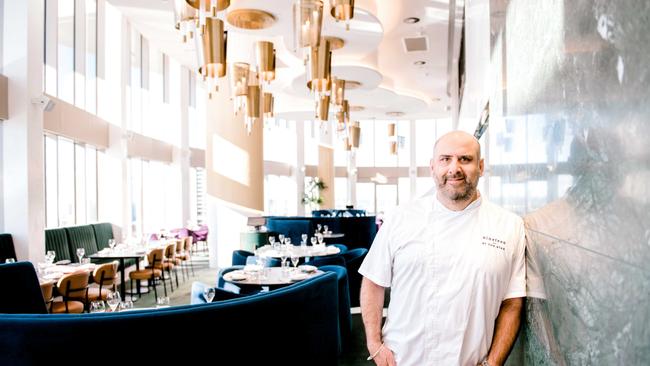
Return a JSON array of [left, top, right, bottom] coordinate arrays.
[[0, 273, 339, 365]]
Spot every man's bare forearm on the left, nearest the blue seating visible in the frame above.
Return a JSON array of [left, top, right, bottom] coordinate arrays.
[[360, 277, 384, 353]]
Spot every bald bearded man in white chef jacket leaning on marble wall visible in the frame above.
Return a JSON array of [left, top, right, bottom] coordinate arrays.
[[359, 131, 526, 366]]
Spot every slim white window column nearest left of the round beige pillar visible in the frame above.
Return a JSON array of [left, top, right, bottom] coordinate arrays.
[[175, 67, 190, 226]]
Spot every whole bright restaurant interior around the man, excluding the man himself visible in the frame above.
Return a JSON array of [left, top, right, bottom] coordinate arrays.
[[0, 0, 650, 366]]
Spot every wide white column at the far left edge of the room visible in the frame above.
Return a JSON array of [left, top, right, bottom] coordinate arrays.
[[2, 0, 45, 262]]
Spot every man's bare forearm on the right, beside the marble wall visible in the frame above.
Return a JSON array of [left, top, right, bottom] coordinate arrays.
[[487, 297, 524, 366]]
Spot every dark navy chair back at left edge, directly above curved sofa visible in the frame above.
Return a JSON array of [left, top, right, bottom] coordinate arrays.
[[0, 262, 47, 314]]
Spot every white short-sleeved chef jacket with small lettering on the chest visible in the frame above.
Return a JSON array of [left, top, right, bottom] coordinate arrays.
[[359, 192, 526, 366]]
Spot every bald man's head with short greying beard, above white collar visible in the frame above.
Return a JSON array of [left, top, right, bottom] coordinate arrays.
[[431, 135, 483, 201]]
